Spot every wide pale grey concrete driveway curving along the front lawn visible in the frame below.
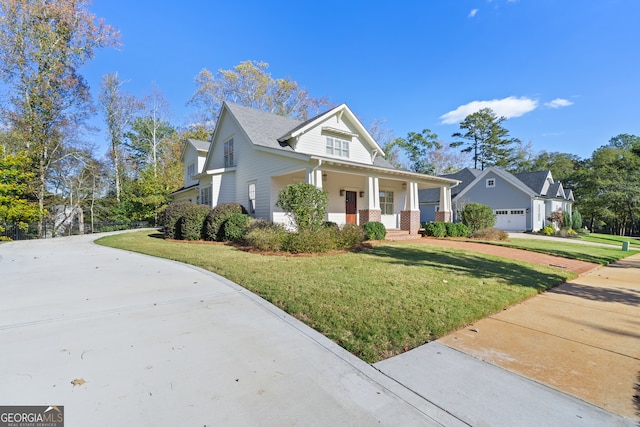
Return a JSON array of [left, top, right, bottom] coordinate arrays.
[[0, 236, 633, 427]]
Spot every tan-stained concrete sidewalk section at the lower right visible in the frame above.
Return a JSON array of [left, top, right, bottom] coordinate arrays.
[[439, 254, 640, 421]]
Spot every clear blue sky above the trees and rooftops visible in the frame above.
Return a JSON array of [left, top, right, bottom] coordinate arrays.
[[81, 0, 640, 158]]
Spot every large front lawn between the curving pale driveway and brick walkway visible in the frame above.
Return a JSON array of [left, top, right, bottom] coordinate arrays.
[[98, 231, 575, 363]]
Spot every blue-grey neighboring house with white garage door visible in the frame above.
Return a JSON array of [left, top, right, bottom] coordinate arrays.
[[419, 167, 574, 231]]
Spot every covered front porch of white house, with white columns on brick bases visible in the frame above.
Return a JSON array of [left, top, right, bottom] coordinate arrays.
[[271, 159, 458, 234]]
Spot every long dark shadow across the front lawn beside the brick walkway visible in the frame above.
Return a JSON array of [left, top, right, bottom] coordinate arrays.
[[368, 246, 566, 292]]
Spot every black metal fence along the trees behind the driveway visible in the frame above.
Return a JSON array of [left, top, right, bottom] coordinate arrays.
[[0, 221, 150, 240]]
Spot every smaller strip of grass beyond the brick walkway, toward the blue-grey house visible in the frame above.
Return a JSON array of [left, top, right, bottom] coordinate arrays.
[[485, 238, 636, 265]]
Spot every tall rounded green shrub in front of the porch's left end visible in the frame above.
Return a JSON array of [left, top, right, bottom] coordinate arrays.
[[276, 182, 328, 231]]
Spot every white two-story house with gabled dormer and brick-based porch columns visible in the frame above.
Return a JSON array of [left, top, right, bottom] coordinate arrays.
[[172, 103, 458, 234]]
